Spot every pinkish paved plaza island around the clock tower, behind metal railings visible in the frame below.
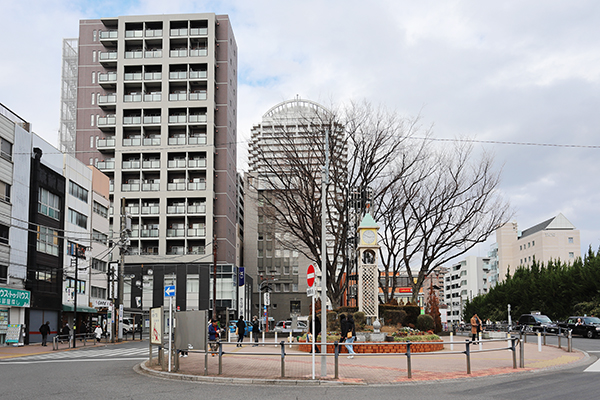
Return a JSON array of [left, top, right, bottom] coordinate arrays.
[[140, 338, 588, 384]]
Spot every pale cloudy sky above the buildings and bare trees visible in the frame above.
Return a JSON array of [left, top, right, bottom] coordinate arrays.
[[0, 0, 600, 256]]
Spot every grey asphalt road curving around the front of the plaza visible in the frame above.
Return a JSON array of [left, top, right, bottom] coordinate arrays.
[[0, 338, 600, 400]]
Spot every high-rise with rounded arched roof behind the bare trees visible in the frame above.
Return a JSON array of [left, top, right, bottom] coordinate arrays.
[[244, 98, 345, 322]]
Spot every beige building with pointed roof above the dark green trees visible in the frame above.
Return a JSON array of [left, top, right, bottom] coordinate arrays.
[[496, 214, 581, 281]]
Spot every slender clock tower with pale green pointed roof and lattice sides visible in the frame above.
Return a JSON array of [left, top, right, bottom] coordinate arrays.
[[357, 213, 379, 323]]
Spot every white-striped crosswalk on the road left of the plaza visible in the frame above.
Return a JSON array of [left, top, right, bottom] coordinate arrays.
[[0, 347, 158, 365]]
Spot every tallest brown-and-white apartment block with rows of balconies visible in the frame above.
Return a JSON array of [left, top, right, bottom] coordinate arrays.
[[65, 13, 238, 322]]
